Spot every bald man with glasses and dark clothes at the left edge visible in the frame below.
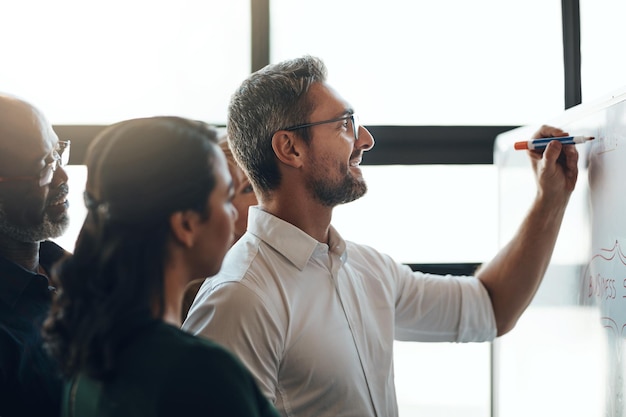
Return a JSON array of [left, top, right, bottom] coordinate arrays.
[[0, 94, 70, 417]]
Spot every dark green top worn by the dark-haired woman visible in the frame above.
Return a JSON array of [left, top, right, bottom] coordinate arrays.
[[63, 321, 279, 417]]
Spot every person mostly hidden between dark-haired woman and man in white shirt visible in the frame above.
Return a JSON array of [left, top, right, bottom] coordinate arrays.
[[181, 137, 258, 321]]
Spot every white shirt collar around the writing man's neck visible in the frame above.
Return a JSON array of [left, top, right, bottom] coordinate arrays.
[[248, 206, 346, 270]]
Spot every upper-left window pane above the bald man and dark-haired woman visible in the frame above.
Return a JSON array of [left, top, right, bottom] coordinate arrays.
[[0, 0, 250, 124]]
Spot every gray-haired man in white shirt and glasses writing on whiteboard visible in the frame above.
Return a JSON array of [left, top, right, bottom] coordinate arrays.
[[183, 57, 578, 417]]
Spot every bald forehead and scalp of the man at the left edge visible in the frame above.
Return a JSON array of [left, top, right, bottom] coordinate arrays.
[[0, 99, 58, 172]]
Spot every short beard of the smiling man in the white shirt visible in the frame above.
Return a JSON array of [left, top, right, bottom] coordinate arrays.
[[308, 162, 367, 207]]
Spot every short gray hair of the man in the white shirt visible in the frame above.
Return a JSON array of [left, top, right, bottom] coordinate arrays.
[[227, 56, 327, 195]]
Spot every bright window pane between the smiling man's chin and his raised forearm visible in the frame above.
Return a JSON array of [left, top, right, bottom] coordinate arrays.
[[333, 164, 498, 263]]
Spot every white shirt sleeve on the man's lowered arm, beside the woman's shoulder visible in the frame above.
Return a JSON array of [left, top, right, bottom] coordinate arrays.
[[183, 281, 284, 403]]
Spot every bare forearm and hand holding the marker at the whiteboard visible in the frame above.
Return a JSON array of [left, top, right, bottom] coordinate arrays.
[[476, 126, 578, 336]]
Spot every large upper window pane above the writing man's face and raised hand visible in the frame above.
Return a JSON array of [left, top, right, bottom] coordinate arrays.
[[270, 0, 564, 126]]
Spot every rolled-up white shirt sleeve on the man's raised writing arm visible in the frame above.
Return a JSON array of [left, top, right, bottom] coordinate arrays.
[[349, 245, 497, 342]]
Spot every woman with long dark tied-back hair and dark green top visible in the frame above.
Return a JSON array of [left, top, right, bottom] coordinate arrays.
[[44, 117, 277, 417]]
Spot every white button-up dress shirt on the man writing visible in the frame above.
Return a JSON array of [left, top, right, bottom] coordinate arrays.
[[183, 207, 496, 417]]
